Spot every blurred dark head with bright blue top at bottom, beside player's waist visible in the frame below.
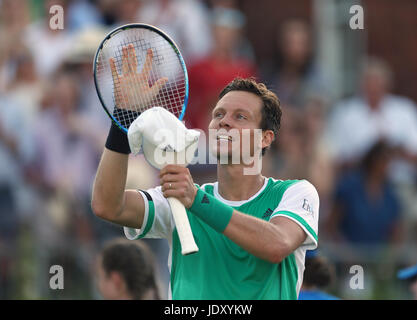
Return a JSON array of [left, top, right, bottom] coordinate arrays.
[[298, 250, 339, 300]]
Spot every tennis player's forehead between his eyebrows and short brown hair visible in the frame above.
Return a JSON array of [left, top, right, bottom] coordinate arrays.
[[213, 91, 262, 115]]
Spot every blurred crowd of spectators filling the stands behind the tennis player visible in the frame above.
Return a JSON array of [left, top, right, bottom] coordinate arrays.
[[0, 0, 417, 299]]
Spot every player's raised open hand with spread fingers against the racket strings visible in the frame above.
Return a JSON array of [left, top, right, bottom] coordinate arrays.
[[109, 44, 168, 111]]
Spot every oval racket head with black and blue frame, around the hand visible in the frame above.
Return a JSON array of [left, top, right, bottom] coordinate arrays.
[[93, 23, 189, 133]]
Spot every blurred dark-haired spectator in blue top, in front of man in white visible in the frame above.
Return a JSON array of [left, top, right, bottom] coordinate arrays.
[[327, 141, 401, 261]]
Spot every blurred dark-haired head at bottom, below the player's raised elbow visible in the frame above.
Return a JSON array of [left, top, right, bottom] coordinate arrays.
[[97, 238, 160, 300]]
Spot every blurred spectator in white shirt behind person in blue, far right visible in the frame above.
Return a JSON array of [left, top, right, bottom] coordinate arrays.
[[327, 57, 417, 182]]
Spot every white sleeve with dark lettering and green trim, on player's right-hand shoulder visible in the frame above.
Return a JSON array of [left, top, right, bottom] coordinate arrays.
[[270, 180, 320, 250]]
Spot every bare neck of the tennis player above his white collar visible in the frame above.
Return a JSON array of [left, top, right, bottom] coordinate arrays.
[[217, 164, 265, 201]]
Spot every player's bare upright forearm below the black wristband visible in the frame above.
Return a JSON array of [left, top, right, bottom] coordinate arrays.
[[92, 148, 128, 218]]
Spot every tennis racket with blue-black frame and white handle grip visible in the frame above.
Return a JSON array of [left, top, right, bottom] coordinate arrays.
[[93, 24, 198, 255]]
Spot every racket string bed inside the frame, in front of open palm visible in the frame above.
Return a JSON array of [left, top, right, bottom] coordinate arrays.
[[97, 29, 187, 128]]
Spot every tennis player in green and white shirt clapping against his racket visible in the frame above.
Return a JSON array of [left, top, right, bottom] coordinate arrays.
[[92, 74, 319, 300]]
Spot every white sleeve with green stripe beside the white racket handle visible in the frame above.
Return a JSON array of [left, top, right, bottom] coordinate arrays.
[[123, 187, 174, 240]]
